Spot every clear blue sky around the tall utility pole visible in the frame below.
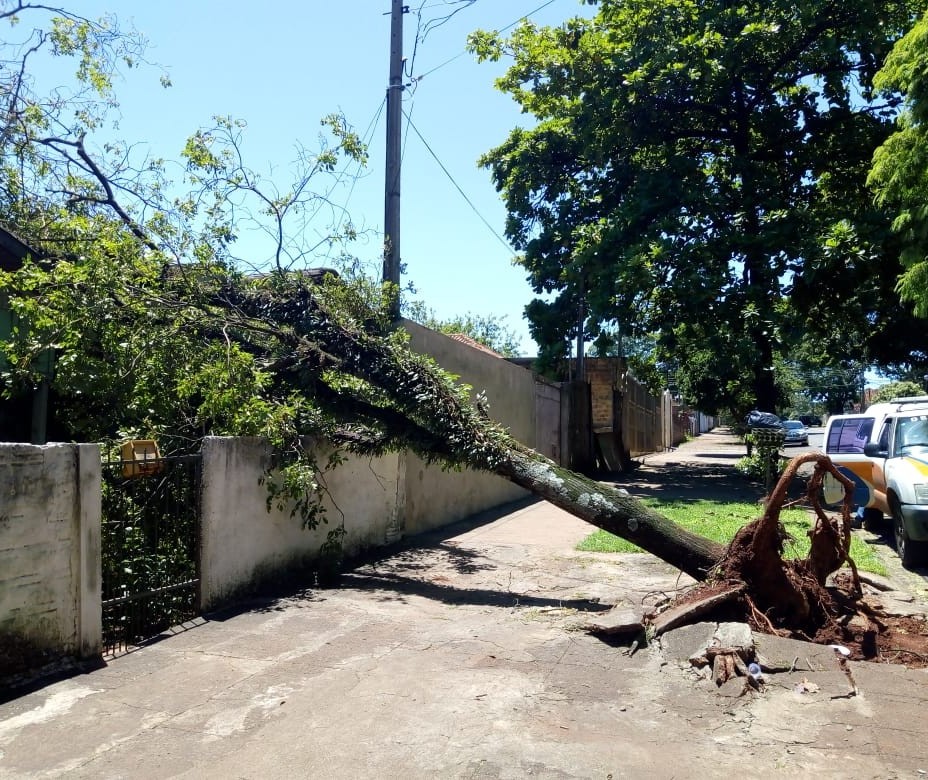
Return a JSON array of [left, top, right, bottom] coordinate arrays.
[[56, 0, 590, 354]]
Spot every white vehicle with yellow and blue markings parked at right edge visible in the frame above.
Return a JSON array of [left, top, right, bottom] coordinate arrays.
[[823, 396, 928, 568]]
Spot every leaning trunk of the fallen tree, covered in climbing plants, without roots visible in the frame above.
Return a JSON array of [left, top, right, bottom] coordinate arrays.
[[217, 278, 724, 579]]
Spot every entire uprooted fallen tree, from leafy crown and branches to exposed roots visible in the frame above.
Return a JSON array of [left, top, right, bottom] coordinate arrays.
[[0, 4, 916, 660]]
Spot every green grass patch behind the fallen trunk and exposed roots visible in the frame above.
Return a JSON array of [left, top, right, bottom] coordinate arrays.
[[577, 499, 888, 575]]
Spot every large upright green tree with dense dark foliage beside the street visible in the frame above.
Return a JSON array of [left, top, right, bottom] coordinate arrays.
[[471, 0, 924, 420]]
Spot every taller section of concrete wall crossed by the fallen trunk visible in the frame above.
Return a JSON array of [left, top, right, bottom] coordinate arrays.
[[403, 320, 536, 535]]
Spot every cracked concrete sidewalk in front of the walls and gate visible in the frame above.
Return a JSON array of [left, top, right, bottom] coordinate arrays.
[[0, 430, 928, 780]]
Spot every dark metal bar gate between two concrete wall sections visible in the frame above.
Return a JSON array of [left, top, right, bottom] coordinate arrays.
[[101, 455, 200, 653]]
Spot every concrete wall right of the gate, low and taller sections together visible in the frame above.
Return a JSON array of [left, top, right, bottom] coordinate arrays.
[[201, 321, 548, 609]]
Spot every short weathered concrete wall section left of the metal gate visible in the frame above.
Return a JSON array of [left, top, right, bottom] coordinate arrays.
[[0, 444, 102, 657]]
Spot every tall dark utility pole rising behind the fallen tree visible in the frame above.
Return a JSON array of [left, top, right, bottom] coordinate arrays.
[[383, 0, 409, 319]]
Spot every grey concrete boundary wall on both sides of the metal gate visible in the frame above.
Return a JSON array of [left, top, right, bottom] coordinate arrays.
[[0, 322, 563, 656]]
